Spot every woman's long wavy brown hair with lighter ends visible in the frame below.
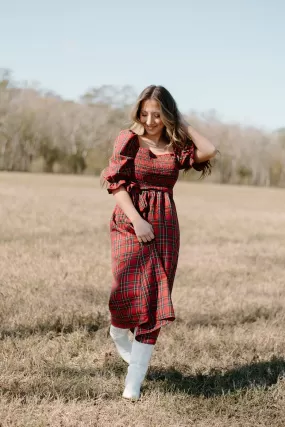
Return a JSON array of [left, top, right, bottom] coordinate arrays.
[[130, 85, 212, 178]]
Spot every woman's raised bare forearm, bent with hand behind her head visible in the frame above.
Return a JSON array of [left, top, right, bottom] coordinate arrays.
[[183, 118, 215, 163]]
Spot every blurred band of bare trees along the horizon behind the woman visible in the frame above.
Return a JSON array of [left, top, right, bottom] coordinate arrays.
[[0, 70, 285, 187]]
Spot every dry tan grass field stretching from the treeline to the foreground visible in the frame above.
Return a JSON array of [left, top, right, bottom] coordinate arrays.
[[0, 173, 285, 427]]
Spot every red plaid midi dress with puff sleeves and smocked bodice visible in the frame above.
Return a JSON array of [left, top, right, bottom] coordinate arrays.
[[103, 130, 199, 335]]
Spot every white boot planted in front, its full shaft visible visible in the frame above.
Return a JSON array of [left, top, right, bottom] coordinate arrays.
[[123, 338, 154, 400]]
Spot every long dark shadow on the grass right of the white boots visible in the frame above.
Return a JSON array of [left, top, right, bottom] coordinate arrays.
[[147, 357, 285, 397]]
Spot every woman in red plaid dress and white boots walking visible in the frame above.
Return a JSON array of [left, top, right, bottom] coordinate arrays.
[[102, 85, 217, 399]]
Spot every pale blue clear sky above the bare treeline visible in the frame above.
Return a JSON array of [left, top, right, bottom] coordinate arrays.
[[0, 0, 285, 130]]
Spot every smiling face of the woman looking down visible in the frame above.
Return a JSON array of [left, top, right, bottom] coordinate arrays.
[[140, 99, 164, 136]]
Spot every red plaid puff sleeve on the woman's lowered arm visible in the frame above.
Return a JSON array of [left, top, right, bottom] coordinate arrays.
[[103, 130, 138, 194]]
